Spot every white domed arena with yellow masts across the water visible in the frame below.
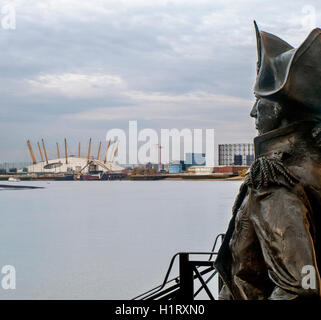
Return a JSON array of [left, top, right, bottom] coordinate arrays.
[[27, 138, 124, 174]]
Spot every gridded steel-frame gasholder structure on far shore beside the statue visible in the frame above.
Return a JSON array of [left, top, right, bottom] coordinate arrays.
[[218, 143, 254, 166]]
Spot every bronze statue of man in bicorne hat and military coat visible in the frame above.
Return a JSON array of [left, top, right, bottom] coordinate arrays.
[[215, 23, 321, 300]]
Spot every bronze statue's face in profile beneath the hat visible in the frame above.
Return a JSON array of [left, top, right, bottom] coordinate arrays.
[[250, 97, 282, 134]]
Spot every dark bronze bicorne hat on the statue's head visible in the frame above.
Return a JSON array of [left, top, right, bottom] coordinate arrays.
[[254, 22, 321, 114]]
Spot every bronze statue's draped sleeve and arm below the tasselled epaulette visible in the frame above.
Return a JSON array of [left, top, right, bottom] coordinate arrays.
[[249, 187, 320, 299]]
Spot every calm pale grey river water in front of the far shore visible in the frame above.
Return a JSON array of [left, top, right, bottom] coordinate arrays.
[[0, 181, 240, 299]]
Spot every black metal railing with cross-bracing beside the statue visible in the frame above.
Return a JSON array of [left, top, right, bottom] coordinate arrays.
[[133, 234, 224, 301]]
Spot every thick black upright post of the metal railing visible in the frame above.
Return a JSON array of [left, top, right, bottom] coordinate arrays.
[[178, 253, 194, 301]]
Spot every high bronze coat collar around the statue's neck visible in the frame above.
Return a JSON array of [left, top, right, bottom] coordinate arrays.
[[254, 121, 315, 159]]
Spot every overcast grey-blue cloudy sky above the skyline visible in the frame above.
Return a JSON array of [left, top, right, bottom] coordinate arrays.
[[0, 0, 321, 161]]
